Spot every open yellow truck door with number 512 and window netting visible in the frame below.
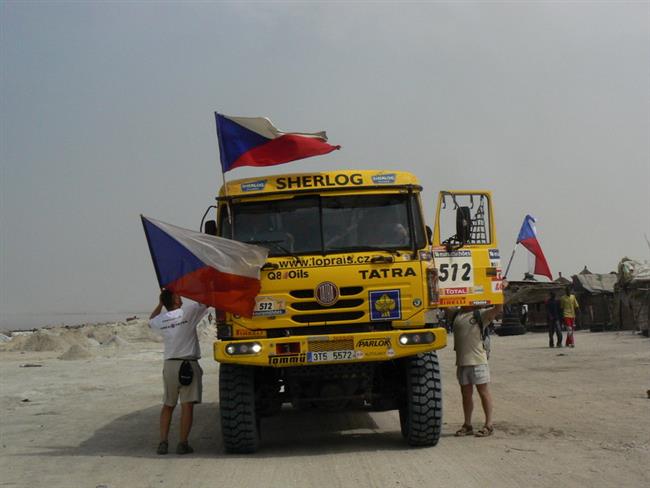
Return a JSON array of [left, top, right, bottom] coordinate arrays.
[[433, 191, 503, 308]]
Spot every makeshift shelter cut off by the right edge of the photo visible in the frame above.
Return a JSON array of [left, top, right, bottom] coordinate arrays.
[[615, 258, 650, 337]]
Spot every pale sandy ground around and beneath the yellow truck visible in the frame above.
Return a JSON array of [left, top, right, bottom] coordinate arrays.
[[0, 322, 650, 488]]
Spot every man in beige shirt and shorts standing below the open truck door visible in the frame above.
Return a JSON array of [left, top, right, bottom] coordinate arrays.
[[453, 305, 502, 437]]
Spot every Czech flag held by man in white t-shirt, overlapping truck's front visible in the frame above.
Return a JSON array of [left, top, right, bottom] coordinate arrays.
[[141, 215, 268, 317]]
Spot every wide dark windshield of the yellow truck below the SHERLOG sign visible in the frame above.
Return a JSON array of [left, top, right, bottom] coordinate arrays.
[[220, 194, 425, 256]]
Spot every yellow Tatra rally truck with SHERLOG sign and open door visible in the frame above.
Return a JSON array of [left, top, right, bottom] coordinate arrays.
[[202, 170, 503, 453]]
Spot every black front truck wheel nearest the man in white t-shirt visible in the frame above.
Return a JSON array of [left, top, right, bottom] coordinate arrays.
[[219, 364, 260, 454]]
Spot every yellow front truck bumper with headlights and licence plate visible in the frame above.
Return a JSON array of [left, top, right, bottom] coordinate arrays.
[[213, 327, 447, 368]]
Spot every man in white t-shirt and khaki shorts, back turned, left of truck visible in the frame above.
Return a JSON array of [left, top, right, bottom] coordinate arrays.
[[149, 290, 207, 454]]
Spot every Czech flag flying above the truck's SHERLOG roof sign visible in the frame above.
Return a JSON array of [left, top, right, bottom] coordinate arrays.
[[214, 112, 341, 173]]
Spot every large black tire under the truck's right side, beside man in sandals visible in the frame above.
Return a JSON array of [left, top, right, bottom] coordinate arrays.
[[399, 352, 442, 446]]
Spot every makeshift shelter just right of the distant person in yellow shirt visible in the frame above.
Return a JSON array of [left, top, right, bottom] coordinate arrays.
[[573, 266, 618, 332]]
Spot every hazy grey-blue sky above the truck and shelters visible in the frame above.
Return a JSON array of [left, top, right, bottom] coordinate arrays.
[[0, 1, 650, 326]]
